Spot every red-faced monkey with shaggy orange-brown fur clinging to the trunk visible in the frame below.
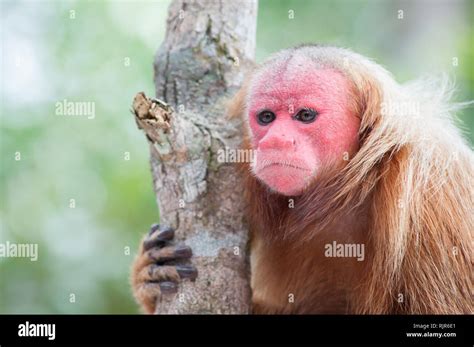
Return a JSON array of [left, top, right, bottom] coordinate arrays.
[[132, 45, 474, 314]]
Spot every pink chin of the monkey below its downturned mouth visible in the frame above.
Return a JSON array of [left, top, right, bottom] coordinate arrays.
[[257, 165, 311, 196]]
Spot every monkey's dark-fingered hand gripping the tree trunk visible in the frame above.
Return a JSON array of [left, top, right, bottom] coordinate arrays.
[[132, 224, 197, 313]]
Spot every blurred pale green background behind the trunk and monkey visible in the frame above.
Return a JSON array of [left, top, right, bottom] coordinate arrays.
[[0, 0, 474, 313]]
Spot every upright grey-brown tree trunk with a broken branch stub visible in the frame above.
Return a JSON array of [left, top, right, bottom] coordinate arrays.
[[134, 0, 257, 314]]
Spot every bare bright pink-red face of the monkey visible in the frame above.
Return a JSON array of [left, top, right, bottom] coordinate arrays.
[[248, 57, 360, 195]]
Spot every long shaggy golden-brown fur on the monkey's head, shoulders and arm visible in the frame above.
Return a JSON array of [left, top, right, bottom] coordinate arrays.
[[237, 46, 474, 314]]
